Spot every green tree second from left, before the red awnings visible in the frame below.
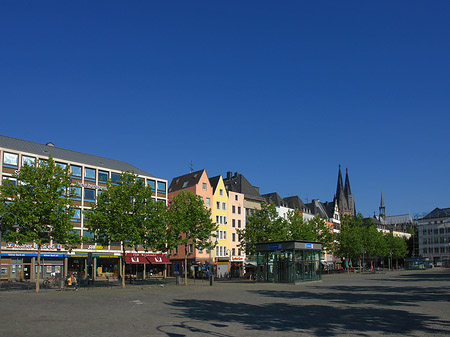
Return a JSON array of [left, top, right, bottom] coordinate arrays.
[[85, 172, 167, 288]]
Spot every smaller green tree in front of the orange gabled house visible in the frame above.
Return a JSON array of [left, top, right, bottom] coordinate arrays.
[[167, 190, 218, 285]]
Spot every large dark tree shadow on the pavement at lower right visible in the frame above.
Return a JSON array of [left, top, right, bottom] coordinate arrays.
[[167, 299, 450, 336]]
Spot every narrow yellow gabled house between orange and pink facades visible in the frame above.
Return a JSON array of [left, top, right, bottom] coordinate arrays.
[[209, 175, 230, 277]]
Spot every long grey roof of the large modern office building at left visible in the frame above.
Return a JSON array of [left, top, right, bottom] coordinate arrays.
[[0, 135, 153, 177]]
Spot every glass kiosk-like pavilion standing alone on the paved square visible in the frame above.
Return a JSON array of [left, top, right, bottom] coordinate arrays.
[[256, 241, 322, 283]]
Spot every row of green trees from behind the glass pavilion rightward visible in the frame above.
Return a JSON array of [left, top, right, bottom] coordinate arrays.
[[239, 203, 408, 265]]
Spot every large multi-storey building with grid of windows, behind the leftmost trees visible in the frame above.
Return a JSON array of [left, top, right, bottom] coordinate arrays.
[[0, 136, 168, 280]]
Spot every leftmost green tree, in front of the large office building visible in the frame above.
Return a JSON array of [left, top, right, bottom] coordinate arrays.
[[0, 156, 82, 292]]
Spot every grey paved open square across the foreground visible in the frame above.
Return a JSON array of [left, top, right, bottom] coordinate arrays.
[[0, 269, 450, 337]]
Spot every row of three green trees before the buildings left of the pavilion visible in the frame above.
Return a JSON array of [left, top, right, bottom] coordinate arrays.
[[0, 157, 217, 292]]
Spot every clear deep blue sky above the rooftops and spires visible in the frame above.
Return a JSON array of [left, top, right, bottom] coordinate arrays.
[[0, 0, 450, 216]]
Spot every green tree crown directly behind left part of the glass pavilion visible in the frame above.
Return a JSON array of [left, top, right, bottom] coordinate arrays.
[[236, 203, 286, 254]]
